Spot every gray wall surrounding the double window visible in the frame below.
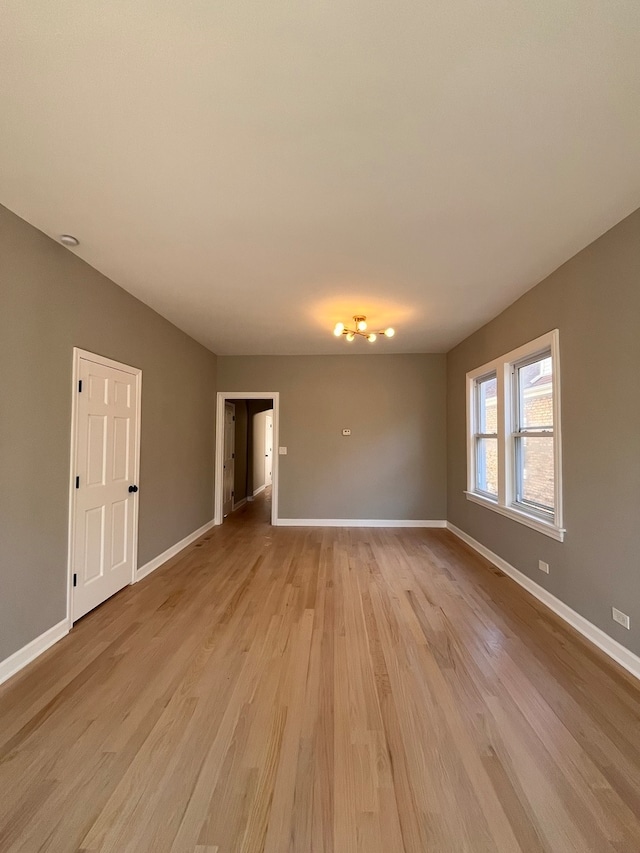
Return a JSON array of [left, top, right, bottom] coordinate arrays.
[[447, 211, 640, 653]]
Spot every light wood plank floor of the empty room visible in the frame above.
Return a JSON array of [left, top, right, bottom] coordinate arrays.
[[0, 490, 640, 853]]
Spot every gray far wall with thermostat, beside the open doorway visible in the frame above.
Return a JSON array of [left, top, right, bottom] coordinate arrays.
[[218, 354, 446, 519]]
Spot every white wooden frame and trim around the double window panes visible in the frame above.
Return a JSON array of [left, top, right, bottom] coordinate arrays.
[[465, 329, 566, 542]]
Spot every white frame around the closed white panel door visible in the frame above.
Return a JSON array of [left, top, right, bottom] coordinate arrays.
[[67, 347, 142, 630]]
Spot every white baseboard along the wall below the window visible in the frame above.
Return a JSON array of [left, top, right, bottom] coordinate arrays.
[[447, 522, 640, 678]]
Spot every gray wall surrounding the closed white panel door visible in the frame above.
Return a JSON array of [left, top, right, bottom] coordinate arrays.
[[0, 207, 216, 660]]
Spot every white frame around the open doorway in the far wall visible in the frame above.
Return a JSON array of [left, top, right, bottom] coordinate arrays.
[[214, 391, 280, 525]]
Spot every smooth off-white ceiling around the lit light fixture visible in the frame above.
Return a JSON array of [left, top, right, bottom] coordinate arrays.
[[0, 0, 640, 354]]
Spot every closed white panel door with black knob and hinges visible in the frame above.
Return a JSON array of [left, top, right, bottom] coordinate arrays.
[[72, 357, 140, 622]]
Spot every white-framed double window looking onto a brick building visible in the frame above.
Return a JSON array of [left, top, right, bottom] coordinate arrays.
[[466, 330, 565, 541]]
